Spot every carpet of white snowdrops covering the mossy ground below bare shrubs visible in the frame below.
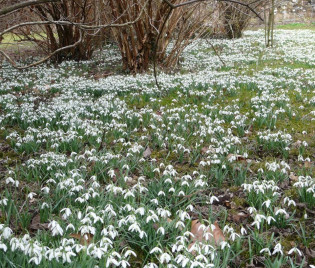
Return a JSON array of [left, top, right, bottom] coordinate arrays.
[[0, 30, 315, 268]]
